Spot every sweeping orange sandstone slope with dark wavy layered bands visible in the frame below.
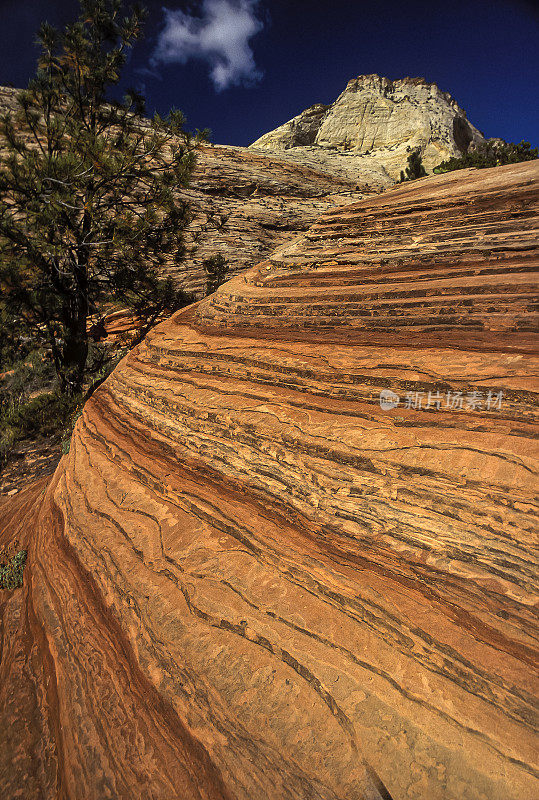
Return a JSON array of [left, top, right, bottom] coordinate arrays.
[[0, 162, 539, 800]]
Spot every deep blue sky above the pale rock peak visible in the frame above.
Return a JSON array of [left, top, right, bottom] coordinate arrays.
[[0, 0, 539, 146]]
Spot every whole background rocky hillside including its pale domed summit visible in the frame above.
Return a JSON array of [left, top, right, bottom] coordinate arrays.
[[0, 75, 490, 295]]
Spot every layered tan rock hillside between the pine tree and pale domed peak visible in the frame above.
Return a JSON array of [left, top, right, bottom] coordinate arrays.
[[0, 87, 368, 295]]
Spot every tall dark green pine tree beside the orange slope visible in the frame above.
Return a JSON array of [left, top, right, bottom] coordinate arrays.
[[0, 0, 199, 395]]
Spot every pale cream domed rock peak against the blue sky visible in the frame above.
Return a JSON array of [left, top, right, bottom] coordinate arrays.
[[251, 75, 484, 185]]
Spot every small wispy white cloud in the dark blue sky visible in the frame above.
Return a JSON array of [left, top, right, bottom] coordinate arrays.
[[150, 0, 263, 92]]
